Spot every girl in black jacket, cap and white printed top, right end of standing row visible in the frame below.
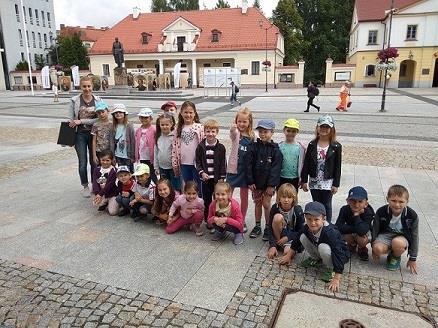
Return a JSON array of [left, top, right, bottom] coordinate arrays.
[[301, 115, 342, 222]]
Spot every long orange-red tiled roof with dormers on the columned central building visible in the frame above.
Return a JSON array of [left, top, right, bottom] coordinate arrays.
[[89, 8, 280, 55]]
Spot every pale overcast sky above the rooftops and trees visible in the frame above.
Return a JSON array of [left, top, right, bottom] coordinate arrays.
[[53, 0, 278, 28]]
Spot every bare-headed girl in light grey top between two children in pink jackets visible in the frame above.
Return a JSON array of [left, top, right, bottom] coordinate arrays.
[[154, 113, 181, 191]]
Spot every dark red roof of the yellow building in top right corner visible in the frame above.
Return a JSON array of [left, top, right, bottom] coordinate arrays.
[[356, 0, 422, 22]]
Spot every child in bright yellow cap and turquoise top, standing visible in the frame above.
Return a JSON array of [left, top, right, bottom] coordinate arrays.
[[278, 118, 306, 191]]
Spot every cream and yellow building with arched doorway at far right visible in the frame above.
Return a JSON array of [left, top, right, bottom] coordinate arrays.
[[347, 0, 438, 88]]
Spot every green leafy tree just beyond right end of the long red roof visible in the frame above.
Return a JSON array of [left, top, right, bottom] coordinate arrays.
[[272, 0, 306, 65]]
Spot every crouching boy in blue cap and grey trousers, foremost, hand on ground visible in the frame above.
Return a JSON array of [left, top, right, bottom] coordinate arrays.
[[291, 202, 350, 292]]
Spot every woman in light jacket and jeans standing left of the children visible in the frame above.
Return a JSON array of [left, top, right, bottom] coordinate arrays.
[[69, 76, 101, 198]]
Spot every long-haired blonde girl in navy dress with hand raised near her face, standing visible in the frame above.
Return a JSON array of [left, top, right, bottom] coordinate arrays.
[[226, 107, 254, 232]]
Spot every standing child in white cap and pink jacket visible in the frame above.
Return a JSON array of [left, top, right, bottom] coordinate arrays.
[[135, 108, 157, 183]]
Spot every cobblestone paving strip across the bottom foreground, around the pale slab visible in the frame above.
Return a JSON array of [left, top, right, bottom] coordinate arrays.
[[0, 257, 438, 328]]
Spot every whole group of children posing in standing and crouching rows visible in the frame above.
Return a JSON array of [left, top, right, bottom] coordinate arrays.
[[84, 101, 418, 291]]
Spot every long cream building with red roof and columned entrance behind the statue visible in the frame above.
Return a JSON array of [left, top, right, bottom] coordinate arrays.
[[89, 6, 290, 87]]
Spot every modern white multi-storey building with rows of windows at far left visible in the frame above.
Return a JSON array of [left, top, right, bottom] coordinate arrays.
[[0, 0, 56, 88]]
